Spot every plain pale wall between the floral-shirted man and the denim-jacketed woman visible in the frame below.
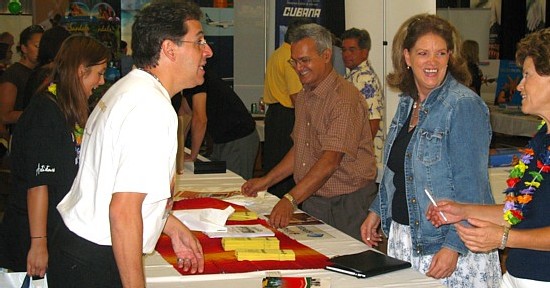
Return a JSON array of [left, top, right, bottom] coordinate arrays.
[[345, 0, 436, 131]]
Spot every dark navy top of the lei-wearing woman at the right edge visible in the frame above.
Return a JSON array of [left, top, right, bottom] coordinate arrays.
[[506, 125, 550, 282]]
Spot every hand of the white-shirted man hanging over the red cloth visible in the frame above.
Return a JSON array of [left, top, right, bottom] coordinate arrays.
[[164, 215, 204, 274]]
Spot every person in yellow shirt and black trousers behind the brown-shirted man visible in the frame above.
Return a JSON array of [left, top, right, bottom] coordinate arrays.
[[262, 18, 311, 198]]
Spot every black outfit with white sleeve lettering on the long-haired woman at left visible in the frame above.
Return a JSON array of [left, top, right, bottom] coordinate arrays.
[[0, 93, 80, 271]]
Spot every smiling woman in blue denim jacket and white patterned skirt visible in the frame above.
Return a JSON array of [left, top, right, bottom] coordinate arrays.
[[361, 14, 501, 287]]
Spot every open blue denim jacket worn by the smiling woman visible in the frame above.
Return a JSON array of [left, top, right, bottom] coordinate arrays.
[[376, 74, 494, 256]]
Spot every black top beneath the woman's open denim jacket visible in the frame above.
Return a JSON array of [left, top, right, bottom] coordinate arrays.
[[388, 106, 416, 225]]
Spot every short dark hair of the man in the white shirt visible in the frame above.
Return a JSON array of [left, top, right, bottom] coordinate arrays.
[[132, 1, 202, 68]]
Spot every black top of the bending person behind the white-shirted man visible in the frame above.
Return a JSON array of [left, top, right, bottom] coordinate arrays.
[[182, 69, 256, 144]]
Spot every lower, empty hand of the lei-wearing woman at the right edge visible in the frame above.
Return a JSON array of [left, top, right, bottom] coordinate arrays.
[[455, 218, 503, 252]]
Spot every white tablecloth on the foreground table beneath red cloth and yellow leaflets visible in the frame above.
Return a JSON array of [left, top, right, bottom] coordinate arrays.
[[145, 161, 443, 288]]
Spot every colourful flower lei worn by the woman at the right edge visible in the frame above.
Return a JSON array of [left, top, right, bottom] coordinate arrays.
[[503, 121, 550, 225]]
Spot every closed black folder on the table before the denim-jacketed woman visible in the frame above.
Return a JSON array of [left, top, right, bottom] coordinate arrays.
[[325, 250, 411, 278]]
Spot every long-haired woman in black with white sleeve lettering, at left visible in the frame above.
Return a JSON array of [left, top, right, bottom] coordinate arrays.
[[0, 36, 110, 277]]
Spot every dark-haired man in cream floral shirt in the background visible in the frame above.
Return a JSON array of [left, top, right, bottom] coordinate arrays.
[[341, 28, 384, 164]]
